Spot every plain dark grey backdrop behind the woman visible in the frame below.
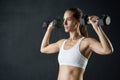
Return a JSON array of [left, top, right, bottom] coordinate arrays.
[[0, 0, 120, 80]]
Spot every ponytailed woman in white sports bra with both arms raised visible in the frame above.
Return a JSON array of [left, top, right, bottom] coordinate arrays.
[[40, 8, 113, 80]]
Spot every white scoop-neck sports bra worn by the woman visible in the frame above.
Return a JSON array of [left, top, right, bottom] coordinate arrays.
[[58, 37, 88, 69]]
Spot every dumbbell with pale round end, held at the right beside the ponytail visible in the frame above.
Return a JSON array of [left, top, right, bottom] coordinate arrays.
[[80, 15, 111, 26]]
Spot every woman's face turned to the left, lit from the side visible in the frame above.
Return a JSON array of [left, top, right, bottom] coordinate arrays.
[[63, 11, 78, 32]]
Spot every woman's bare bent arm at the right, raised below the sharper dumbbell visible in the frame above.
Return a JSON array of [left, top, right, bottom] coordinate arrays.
[[89, 17, 113, 55]]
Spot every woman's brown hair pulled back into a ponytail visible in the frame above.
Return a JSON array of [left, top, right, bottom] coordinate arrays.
[[67, 8, 88, 37]]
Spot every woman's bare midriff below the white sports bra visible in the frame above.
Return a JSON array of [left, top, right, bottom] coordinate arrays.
[[58, 65, 84, 80]]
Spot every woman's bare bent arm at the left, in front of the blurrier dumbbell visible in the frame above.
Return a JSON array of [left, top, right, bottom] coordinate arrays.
[[40, 22, 63, 54]]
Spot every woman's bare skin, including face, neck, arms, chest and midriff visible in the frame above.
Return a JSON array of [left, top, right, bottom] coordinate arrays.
[[40, 11, 113, 80]]
